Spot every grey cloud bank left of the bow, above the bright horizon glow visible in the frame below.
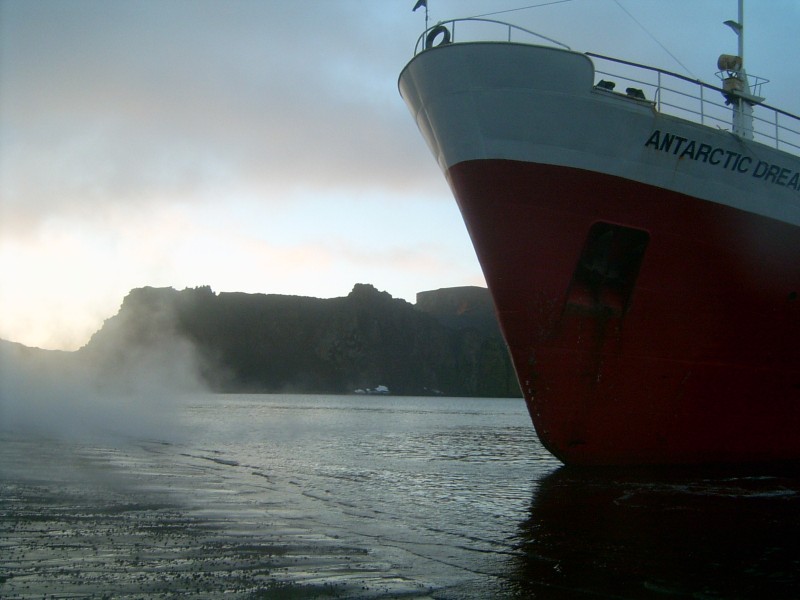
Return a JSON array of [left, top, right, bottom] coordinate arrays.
[[0, 1, 439, 234]]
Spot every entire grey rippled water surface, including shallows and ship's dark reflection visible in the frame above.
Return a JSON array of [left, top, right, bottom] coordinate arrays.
[[0, 395, 800, 599]]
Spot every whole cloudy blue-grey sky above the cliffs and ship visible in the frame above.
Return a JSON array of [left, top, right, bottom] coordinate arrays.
[[0, 0, 800, 350]]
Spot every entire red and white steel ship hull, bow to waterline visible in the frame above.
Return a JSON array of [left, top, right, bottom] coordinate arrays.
[[400, 43, 800, 465]]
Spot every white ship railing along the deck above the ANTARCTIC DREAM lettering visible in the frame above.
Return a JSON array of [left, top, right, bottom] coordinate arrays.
[[586, 52, 800, 154]]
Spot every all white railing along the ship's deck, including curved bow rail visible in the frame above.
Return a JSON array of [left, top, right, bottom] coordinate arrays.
[[414, 18, 800, 154]]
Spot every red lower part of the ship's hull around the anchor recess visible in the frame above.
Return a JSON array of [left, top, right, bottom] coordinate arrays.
[[447, 159, 800, 465]]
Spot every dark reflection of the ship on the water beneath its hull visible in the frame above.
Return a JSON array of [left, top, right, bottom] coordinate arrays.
[[510, 467, 800, 598]]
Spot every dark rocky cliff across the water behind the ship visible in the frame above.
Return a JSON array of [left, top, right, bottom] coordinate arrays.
[[79, 284, 520, 397]]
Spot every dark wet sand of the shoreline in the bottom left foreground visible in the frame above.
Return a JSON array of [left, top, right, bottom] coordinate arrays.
[[0, 439, 438, 598]]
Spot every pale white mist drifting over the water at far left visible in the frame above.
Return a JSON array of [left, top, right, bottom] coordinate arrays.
[[0, 334, 207, 444]]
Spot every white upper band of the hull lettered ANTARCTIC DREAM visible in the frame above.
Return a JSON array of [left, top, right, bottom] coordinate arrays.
[[400, 42, 800, 226]]
